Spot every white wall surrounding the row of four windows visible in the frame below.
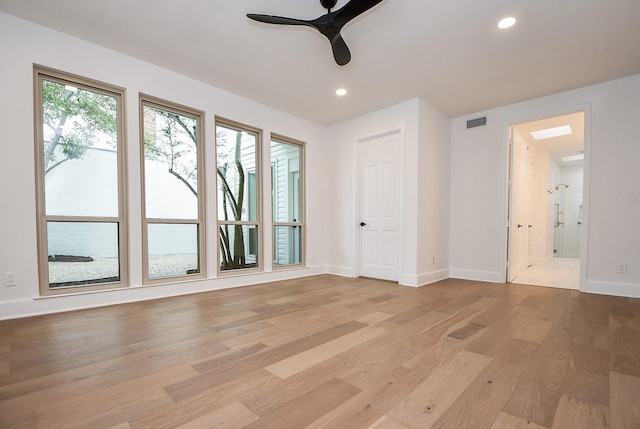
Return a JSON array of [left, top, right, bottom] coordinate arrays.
[[0, 13, 330, 319]]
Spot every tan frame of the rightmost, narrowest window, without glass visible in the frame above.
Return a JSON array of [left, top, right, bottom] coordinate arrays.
[[269, 133, 307, 271]]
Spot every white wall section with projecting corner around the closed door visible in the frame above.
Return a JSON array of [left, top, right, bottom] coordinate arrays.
[[328, 99, 451, 286]]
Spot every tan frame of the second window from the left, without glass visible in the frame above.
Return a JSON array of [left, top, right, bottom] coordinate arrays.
[[138, 93, 207, 285]]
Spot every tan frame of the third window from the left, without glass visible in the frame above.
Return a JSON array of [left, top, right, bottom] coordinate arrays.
[[214, 116, 264, 277]]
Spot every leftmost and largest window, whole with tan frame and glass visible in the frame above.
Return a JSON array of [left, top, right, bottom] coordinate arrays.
[[34, 67, 127, 294]]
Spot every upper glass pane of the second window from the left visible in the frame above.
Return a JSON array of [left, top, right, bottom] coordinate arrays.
[[143, 106, 198, 219]]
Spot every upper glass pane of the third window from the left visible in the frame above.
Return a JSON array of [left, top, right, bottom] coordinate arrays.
[[216, 125, 258, 221]]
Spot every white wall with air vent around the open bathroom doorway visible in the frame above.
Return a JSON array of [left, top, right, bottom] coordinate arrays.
[[450, 75, 640, 296]]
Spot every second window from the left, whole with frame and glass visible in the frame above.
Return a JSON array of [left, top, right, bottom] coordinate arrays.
[[140, 96, 205, 283]]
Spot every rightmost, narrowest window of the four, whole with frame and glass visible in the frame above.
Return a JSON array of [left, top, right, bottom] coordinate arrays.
[[271, 135, 304, 268]]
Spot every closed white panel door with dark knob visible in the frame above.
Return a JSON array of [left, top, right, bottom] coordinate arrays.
[[358, 131, 402, 281]]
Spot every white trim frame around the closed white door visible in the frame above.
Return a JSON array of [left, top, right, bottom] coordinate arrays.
[[353, 124, 405, 284]]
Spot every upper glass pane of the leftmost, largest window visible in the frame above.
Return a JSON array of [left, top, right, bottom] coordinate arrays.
[[42, 80, 118, 217]]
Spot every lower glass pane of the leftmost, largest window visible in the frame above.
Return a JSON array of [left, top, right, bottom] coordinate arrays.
[[47, 222, 120, 289]]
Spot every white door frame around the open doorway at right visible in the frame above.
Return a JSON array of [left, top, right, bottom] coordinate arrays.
[[501, 104, 591, 292]]
